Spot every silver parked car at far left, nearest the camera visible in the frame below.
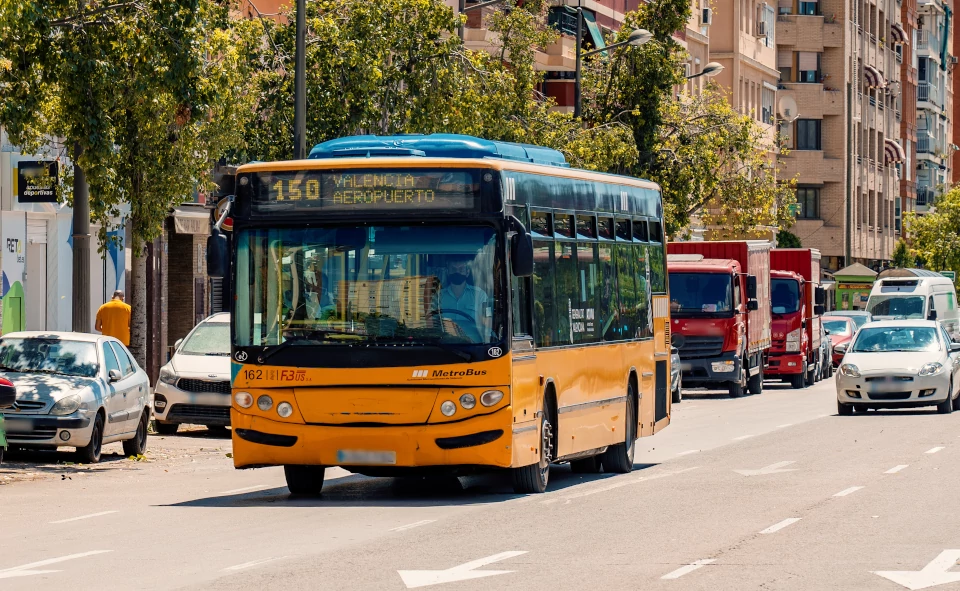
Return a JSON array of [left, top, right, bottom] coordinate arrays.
[[0, 332, 150, 464]]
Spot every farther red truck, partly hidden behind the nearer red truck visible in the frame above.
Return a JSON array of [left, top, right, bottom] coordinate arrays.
[[767, 248, 824, 388]]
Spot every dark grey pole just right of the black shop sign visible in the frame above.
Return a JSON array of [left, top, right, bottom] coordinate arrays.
[[72, 144, 91, 332]]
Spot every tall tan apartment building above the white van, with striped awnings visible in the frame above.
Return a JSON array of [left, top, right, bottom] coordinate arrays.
[[777, 0, 904, 270]]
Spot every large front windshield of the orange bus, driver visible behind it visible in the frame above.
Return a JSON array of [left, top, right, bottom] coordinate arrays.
[[234, 225, 505, 346]]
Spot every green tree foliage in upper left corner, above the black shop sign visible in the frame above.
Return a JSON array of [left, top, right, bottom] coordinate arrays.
[[0, 0, 249, 248]]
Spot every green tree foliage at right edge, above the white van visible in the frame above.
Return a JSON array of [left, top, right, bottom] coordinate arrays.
[[897, 189, 960, 271]]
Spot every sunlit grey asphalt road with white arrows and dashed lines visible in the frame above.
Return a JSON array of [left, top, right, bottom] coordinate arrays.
[[0, 380, 960, 591]]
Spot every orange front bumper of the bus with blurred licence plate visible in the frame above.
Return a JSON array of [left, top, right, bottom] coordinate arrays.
[[231, 406, 513, 469]]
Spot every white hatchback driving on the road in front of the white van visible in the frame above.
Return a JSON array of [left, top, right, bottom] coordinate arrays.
[[837, 320, 960, 415]]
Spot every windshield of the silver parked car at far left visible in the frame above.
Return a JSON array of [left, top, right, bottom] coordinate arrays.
[[0, 337, 100, 378]]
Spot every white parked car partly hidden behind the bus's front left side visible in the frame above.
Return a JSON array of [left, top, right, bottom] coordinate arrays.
[[153, 312, 230, 435]]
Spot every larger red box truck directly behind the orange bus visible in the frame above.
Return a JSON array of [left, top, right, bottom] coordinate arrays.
[[667, 240, 771, 397]]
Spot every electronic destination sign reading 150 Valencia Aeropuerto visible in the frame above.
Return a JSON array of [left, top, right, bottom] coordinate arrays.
[[253, 169, 480, 213]]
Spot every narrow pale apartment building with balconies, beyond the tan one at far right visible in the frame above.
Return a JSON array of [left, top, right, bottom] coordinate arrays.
[[911, 0, 957, 213]]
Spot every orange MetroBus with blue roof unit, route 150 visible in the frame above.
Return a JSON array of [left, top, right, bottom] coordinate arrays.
[[208, 135, 670, 495]]
